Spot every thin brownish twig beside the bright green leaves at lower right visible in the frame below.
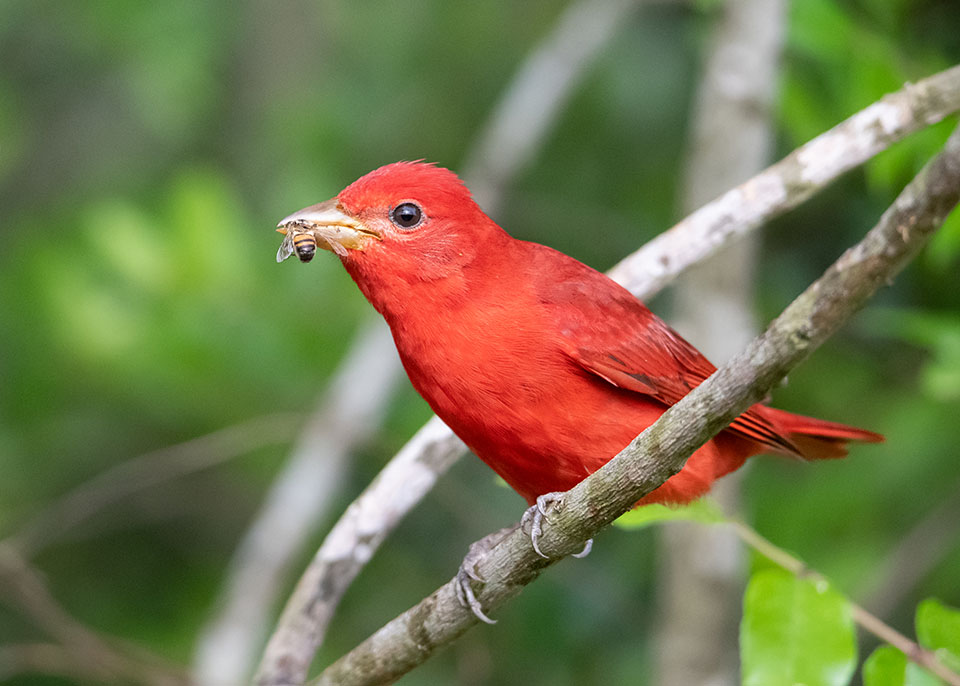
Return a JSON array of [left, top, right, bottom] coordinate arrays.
[[727, 520, 960, 686]]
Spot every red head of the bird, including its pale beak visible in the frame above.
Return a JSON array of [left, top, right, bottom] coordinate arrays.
[[277, 162, 510, 311]]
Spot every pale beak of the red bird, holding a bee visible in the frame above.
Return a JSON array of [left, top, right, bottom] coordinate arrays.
[[277, 198, 381, 262]]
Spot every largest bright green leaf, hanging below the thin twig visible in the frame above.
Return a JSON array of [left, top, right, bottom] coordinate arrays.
[[740, 569, 857, 686]]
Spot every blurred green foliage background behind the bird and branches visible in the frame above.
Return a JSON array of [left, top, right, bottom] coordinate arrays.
[[0, 0, 960, 686]]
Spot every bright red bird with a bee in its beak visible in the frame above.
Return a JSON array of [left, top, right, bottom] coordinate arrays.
[[277, 162, 883, 520]]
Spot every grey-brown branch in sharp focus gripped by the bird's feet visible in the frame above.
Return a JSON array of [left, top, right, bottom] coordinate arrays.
[[314, 128, 960, 686]]
